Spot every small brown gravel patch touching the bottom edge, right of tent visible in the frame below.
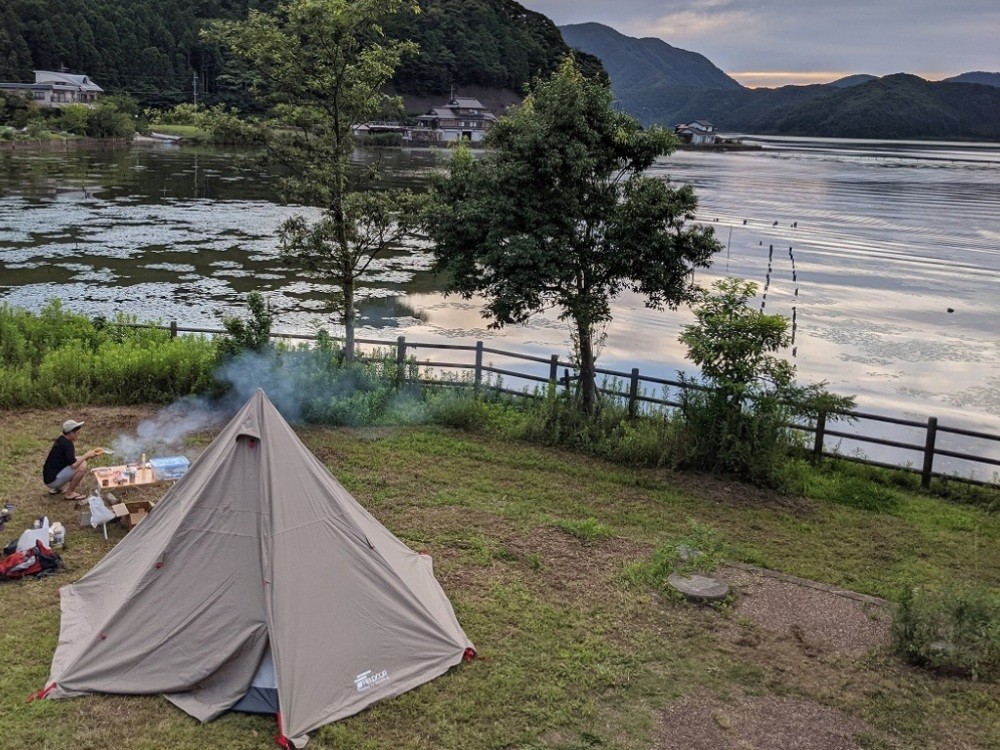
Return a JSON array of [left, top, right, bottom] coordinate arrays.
[[654, 695, 867, 750]]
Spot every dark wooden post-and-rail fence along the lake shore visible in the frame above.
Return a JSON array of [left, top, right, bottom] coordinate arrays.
[[127, 321, 1000, 487]]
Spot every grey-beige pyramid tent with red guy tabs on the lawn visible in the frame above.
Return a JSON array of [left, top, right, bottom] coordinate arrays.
[[36, 390, 475, 748]]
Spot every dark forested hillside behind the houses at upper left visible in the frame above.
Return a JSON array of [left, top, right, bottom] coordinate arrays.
[[0, 0, 603, 106]]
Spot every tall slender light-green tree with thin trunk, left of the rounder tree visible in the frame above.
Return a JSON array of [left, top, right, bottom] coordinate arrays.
[[206, 0, 419, 358]]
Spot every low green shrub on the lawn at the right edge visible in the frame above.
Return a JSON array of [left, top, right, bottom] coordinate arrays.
[[892, 586, 1000, 682]]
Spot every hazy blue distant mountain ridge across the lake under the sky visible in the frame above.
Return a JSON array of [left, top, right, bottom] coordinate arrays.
[[560, 23, 1000, 140]]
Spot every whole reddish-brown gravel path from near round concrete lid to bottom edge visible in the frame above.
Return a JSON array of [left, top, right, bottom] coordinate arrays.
[[653, 567, 896, 750]]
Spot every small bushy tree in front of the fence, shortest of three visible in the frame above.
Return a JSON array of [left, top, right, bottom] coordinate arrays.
[[680, 278, 854, 486]]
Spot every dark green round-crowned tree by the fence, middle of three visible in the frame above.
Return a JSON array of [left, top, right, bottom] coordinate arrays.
[[427, 57, 720, 414]]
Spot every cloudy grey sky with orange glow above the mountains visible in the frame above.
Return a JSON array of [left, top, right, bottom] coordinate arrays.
[[519, 0, 1000, 86]]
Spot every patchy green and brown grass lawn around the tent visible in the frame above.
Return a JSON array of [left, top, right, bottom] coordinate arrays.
[[0, 407, 1000, 750]]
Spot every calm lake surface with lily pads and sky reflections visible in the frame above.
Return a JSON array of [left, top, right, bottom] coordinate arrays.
[[0, 139, 1000, 479]]
